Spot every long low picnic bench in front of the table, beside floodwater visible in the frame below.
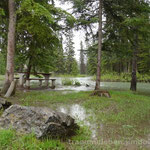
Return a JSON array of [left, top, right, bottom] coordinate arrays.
[[26, 78, 56, 89]]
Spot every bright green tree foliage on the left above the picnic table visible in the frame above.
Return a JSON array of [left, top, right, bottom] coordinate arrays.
[[0, 0, 75, 77]]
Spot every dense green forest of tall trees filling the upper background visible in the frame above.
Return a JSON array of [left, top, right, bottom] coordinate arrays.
[[0, 0, 150, 90]]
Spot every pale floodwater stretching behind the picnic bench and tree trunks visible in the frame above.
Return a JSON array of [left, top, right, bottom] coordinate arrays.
[[0, 77, 150, 95]]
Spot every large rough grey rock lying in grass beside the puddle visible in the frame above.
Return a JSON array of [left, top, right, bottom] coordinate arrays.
[[0, 105, 78, 138]]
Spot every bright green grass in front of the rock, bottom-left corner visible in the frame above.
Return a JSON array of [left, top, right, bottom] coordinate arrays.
[[0, 130, 65, 150]]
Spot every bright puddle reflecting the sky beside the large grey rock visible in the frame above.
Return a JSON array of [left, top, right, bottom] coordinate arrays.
[[57, 104, 98, 138]]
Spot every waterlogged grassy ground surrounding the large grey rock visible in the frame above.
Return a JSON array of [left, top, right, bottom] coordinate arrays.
[[0, 91, 150, 150]]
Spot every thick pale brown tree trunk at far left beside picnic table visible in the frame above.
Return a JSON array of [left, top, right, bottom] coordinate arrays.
[[2, 0, 16, 94]]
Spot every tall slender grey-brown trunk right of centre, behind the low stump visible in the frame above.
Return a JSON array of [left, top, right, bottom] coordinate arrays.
[[95, 0, 103, 90]]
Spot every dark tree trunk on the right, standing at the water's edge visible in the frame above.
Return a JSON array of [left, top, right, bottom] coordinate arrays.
[[130, 35, 138, 91]]
